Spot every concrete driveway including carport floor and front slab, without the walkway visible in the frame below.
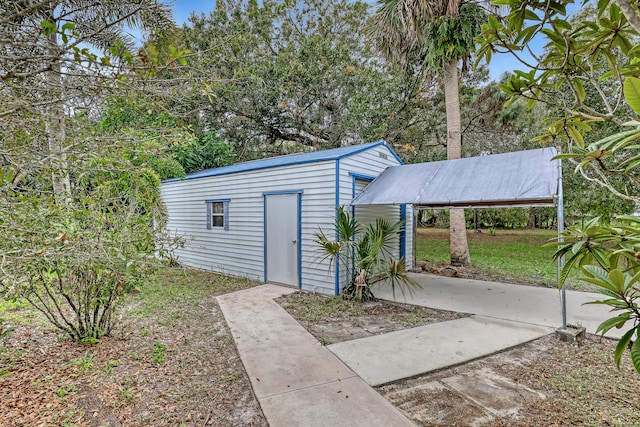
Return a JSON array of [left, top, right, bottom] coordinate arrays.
[[327, 274, 624, 385]]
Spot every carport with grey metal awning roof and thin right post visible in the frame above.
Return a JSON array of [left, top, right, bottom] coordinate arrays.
[[351, 147, 567, 329]]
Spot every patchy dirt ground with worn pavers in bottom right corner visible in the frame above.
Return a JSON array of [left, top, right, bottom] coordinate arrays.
[[378, 335, 640, 427]]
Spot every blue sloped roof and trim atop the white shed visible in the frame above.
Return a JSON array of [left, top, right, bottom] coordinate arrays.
[[162, 141, 404, 183]]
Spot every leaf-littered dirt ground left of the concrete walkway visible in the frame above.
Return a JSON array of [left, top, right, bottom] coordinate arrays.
[[0, 271, 267, 427]]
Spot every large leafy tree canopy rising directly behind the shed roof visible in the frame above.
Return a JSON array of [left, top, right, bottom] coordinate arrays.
[[175, 0, 440, 159]]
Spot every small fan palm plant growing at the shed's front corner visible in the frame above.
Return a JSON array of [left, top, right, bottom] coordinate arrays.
[[315, 206, 418, 301]]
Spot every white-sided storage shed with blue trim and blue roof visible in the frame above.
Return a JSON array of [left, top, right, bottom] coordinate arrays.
[[161, 141, 413, 294]]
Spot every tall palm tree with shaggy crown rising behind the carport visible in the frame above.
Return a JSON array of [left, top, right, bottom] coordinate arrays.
[[371, 0, 486, 265]]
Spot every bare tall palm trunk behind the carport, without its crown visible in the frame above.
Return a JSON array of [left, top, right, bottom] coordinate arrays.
[[444, 58, 471, 265]]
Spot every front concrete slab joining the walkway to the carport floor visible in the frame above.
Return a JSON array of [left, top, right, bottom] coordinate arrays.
[[327, 316, 554, 386]]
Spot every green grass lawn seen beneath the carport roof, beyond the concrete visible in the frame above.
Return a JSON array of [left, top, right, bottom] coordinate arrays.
[[416, 229, 591, 289]]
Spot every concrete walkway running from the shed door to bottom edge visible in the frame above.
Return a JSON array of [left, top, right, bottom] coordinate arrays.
[[217, 284, 414, 427]]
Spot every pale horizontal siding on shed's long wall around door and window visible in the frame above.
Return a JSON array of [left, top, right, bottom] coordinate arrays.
[[162, 161, 335, 294]]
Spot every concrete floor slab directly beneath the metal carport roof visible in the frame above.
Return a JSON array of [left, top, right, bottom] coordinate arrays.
[[372, 274, 624, 338]]
